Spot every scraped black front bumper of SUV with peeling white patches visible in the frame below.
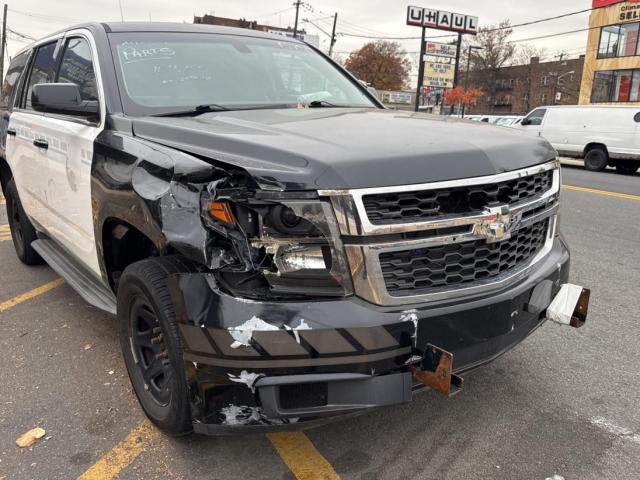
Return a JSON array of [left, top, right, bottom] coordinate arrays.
[[171, 237, 569, 434]]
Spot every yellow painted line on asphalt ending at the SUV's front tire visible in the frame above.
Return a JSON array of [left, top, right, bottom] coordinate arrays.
[[77, 420, 159, 480]]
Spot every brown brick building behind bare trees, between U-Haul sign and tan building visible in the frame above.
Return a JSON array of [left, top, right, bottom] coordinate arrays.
[[461, 55, 584, 115]]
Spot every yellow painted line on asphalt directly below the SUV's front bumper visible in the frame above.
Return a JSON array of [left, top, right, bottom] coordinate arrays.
[[267, 432, 340, 480]]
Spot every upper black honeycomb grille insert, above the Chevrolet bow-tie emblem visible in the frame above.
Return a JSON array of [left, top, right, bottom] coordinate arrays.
[[362, 171, 553, 225]]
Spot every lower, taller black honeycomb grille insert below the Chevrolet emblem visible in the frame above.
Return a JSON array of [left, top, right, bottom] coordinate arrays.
[[380, 219, 549, 296]]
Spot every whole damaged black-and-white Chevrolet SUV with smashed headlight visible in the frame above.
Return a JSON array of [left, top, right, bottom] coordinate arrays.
[[0, 23, 588, 434]]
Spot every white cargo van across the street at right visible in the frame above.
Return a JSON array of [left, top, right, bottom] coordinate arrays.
[[520, 105, 640, 174]]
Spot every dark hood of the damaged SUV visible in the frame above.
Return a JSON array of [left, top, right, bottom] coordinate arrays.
[[133, 108, 555, 190]]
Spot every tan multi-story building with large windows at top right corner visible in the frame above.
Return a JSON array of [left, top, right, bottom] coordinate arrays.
[[580, 0, 640, 105]]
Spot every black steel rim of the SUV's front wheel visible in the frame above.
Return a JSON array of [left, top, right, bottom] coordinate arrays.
[[130, 297, 172, 406]]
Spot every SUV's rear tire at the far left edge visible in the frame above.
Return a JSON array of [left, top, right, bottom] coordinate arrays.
[[5, 178, 44, 265]]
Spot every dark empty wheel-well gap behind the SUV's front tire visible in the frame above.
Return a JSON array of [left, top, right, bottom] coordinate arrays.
[[102, 219, 160, 292]]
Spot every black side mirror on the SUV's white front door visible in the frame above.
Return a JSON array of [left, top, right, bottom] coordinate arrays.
[[31, 83, 99, 118]]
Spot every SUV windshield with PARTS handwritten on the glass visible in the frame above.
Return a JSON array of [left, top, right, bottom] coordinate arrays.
[[109, 32, 376, 115]]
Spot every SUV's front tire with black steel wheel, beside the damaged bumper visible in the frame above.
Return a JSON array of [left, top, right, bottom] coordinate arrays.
[[118, 256, 193, 436]]
